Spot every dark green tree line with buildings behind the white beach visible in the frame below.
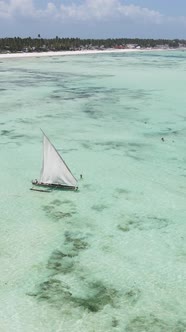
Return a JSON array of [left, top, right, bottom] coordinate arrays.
[[0, 34, 186, 53]]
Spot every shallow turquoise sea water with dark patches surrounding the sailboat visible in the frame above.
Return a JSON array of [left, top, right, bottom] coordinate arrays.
[[0, 51, 186, 332]]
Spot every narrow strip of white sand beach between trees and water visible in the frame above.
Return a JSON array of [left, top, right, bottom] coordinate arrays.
[[0, 48, 179, 59]]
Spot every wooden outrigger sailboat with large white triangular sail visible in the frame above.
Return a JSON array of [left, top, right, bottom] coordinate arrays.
[[31, 131, 78, 191]]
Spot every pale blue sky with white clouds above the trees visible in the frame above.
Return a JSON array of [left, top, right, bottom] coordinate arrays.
[[0, 0, 186, 39]]
